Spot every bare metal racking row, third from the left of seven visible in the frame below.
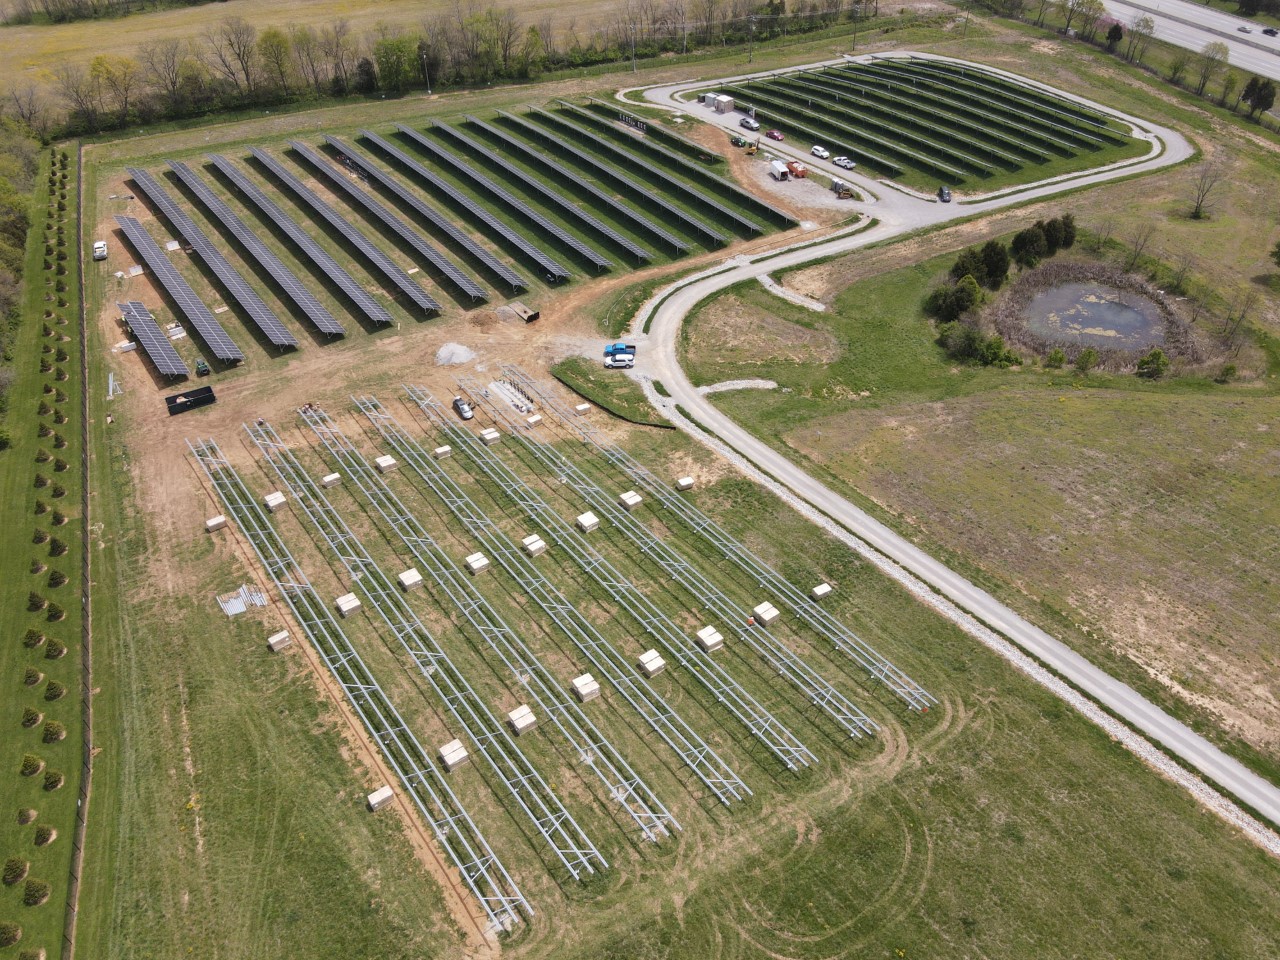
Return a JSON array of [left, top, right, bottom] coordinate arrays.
[[300, 406, 681, 842]]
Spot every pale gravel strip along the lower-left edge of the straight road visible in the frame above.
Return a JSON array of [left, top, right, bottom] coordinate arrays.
[[643, 378, 1280, 856]]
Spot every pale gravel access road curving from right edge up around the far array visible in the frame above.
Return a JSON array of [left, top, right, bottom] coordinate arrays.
[[634, 52, 1280, 824]]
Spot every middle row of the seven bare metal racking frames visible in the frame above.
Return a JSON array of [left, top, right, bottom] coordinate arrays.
[[353, 397, 751, 805]]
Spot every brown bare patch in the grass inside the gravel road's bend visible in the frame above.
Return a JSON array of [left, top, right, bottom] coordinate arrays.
[[687, 296, 841, 365]]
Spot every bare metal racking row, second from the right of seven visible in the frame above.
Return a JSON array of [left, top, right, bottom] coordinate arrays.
[[468, 378, 879, 739]]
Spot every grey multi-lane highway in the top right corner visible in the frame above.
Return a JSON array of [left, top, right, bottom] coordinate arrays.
[[1102, 0, 1280, 81]]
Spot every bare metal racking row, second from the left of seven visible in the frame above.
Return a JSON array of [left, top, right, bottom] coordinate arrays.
[[244, 421, 609, 879]]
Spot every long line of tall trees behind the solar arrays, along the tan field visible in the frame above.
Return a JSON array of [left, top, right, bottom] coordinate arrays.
[[5, 0, 877, 136]]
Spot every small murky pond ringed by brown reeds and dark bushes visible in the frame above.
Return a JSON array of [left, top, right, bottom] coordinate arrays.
[[1023, 283, 1165, 352]]
